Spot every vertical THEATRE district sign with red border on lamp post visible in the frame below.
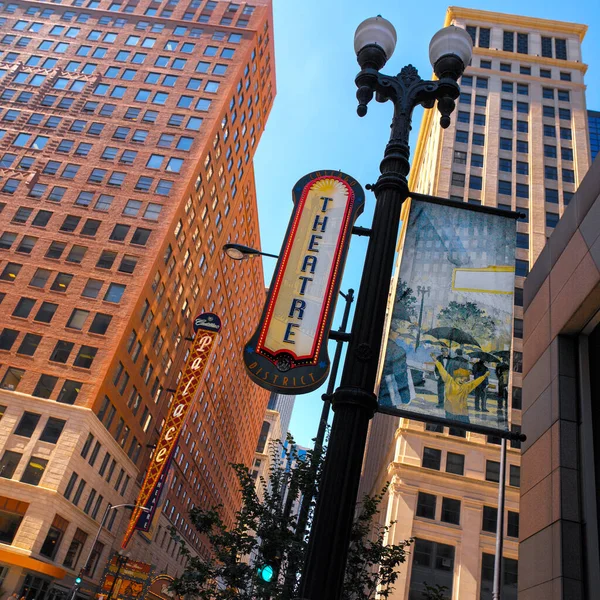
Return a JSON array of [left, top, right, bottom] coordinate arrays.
[[244, 171, 365, 394]]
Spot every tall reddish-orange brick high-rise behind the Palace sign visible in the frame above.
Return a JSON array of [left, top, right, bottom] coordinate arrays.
[[0, 0, 275, 599]]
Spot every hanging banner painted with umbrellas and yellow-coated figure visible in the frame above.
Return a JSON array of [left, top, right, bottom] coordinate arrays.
[[378, 198, 516, 434]]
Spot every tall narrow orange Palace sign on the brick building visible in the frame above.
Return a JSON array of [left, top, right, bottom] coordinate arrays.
[[122, 313, 221, 548]]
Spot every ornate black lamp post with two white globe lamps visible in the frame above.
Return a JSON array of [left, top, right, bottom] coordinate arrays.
[[300, 17, 472, 600]]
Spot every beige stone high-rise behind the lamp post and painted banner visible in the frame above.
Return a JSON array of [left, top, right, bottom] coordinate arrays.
[[361, 7, 590, 600]]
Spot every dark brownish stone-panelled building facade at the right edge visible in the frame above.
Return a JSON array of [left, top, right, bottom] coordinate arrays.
[[519, 152, 600, 600]]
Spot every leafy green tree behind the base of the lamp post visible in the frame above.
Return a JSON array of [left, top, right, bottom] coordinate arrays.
[[172, 438, 412, 600]]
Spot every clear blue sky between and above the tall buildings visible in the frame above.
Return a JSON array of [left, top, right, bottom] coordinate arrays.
[[250, 0, 600, 445]]
